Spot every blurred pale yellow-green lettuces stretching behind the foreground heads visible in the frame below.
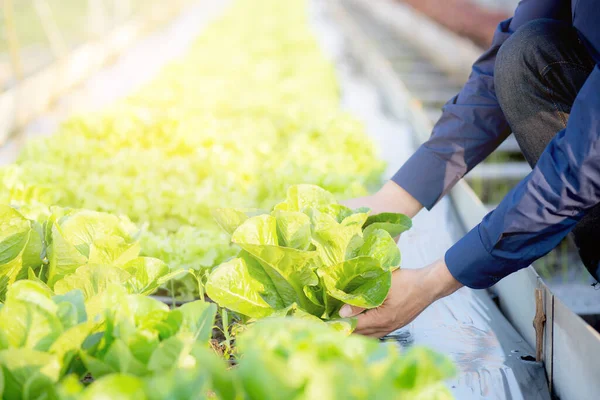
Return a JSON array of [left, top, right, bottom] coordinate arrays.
[[0, 0, 383, 300]]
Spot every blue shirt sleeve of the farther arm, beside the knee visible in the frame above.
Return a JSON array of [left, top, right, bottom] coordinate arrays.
[[392, 0, 570, 209]]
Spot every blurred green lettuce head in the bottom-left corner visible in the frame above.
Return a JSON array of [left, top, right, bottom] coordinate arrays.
[[0, 280, 97, 399]]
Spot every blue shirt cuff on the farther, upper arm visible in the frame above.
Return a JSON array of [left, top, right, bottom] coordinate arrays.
[[392, 145, 455, 210]]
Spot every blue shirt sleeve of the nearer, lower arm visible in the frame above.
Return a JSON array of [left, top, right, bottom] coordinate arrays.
[[446, 65, 600, 288]]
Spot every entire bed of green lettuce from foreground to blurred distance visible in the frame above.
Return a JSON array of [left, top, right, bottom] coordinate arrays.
[[0, 0, 453, 400]]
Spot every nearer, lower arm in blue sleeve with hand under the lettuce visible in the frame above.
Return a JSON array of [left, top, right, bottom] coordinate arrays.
[[340, 52, 600, 337]]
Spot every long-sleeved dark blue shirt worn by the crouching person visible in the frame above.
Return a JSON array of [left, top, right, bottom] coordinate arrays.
[[392, 0, 600, 288]]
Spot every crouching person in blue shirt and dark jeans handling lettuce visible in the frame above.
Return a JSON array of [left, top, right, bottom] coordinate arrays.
[[340, 0, 600, 337]]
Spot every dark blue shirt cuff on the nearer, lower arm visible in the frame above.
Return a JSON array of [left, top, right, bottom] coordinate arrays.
[[445, 225, 510, 289]]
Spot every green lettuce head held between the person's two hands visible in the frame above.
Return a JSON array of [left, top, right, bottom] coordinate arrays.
[[206, 185, 411, 320]]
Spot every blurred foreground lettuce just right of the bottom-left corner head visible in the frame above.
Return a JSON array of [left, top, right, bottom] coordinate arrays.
[[80, 287, 217, 379]]
